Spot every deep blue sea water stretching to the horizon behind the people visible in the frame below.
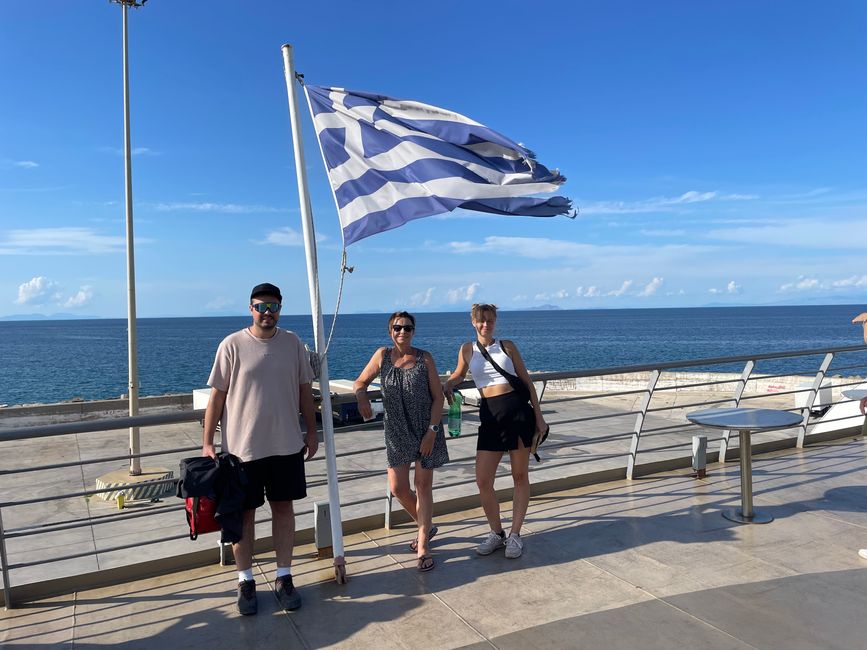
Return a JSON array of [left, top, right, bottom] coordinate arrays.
[[0, 305, 864, 405]]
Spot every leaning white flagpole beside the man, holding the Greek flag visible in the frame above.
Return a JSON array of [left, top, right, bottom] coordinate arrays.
[[282, 45, 346, 584]]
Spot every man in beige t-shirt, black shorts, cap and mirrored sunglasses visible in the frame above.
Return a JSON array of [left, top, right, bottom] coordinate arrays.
[[202, 283, 319, 615]]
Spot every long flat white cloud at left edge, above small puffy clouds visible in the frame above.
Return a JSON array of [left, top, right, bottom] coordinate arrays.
[[0, 228, 129, 255]]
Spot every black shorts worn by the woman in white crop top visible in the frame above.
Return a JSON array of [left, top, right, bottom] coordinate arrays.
[[476, 391, 536, 451]]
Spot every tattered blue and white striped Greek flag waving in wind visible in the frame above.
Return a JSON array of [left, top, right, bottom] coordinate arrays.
[[305, 86, 574, 245]]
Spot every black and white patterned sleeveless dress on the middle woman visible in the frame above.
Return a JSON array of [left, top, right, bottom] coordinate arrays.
[[380, 348, 449, 469]]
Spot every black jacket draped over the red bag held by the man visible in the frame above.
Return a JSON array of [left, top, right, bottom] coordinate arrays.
[[177, 452, 247, 544]]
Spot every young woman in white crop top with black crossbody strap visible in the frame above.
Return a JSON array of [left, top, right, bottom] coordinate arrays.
[[444, 304, 548, 558]]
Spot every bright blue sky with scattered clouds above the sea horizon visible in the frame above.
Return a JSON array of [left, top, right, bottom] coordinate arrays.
[[0, 0, 867, 317]]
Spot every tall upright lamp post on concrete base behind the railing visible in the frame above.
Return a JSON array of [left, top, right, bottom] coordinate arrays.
[[122, 3, 141, 476]]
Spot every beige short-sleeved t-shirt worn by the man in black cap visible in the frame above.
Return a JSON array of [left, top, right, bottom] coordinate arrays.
[[208, 328, 313, 462]]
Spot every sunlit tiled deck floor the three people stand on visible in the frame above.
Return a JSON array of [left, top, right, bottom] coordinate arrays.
[[0, 438, 867, 650]]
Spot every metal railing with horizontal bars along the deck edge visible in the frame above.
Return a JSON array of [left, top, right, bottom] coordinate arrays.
[[0, 345, 867, 607]]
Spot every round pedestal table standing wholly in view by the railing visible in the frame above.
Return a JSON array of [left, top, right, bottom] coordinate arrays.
[[686, 408, 804, 524]]
